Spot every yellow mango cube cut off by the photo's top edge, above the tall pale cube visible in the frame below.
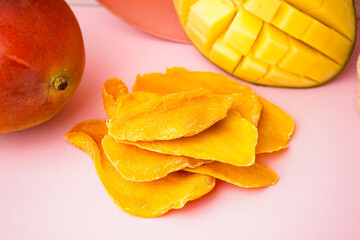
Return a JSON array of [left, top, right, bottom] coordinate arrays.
[[244, 0, 281, 22]]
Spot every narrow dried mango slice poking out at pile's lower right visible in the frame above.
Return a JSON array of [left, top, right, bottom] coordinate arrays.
[[184, 162, 278, 188]]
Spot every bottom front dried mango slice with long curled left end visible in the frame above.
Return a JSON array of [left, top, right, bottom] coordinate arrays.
[[65, 121, 215, 218]]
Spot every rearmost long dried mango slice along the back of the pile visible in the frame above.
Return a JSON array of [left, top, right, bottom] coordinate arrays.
[[132, 67, 261, 126]]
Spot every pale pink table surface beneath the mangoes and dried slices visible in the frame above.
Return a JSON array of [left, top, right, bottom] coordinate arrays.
[[0, 7, 360, 240]]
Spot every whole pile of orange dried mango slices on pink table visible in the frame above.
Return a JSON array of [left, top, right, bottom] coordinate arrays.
[[65, 67, 294, 218]]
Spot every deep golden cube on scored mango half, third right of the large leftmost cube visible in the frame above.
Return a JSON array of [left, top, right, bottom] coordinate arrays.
[[279, 37, 317, 76]]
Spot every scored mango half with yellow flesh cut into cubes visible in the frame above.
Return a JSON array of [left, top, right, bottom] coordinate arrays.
[[174, 0, 357, 88]]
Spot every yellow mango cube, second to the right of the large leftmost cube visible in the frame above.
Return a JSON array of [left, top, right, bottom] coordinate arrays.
[[253, 23, 289, 65]]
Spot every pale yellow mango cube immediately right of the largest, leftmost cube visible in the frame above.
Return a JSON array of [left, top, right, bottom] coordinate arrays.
[[223, 8, 263, 54]]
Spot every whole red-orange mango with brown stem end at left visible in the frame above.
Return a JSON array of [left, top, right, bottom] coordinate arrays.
[[0, 0, 85, 133]]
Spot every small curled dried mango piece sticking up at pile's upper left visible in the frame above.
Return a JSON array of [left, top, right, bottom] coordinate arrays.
[[101, 78, 129, 118]]
